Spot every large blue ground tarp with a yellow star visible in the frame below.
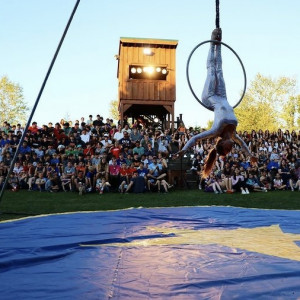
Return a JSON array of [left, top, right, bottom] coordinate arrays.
[[0, 207, 300, 300]]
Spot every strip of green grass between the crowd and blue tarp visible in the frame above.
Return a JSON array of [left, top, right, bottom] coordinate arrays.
[[0, 190, 300, 221]]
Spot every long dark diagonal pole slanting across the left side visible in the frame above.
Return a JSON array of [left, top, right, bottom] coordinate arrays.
[[0, 0, 80, 202]]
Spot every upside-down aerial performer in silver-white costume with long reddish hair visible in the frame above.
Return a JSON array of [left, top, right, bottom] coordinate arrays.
[[175, 28, 257, 178]]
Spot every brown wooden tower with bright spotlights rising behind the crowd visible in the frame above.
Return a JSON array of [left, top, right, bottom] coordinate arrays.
[[117, 37, 178, 128]]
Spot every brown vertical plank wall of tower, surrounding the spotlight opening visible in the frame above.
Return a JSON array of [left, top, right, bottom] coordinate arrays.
[[119, 44, 176, 104]]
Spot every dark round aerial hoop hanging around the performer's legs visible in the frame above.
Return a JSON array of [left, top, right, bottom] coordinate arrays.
[[186, 40, 247, 111]]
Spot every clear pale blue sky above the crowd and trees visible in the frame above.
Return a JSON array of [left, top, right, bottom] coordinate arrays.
[[0, 0, 300, 127]]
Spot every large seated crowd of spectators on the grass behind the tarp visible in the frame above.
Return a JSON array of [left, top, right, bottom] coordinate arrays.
[[0, 115, 300, 194]]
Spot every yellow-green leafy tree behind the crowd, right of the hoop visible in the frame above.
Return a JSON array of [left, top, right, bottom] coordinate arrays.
[[235, 74, 297, 131]]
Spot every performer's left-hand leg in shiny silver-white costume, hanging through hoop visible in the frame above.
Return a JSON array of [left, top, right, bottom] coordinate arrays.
[[202, 43, 217, 107]]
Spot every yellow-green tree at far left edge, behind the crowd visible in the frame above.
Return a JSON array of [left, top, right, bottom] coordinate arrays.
[[0, 76, 29, 124]]
